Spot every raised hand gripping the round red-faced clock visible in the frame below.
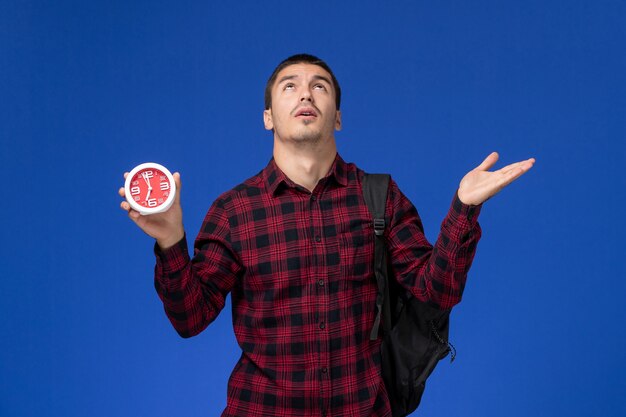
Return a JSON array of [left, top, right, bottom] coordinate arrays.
[[119, 172, 185, 249]]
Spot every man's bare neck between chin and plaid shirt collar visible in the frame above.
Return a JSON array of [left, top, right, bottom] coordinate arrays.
[[274, 137, 337, 192]]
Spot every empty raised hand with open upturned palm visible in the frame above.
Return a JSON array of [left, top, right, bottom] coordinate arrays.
[[458, 152, 535, 205]]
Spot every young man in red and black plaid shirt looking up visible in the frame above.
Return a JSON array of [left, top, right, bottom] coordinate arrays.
[[120, 55, 534, 417]]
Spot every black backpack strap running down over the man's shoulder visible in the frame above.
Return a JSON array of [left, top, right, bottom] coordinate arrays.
[[362, 174, 391, 340]]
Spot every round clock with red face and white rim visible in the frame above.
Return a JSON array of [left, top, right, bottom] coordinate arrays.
[[124, 162, 176, 215]]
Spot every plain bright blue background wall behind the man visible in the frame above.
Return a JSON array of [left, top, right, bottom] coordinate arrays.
[[0, 0, 626, 417]]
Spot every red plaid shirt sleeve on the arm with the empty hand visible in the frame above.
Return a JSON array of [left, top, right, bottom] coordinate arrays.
[[387, 180, 482, 309]]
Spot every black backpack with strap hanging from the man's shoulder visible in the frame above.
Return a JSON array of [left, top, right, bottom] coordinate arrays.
[[363, 174, 456, 417]]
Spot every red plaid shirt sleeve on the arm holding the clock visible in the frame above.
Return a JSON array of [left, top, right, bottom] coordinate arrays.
[[154, 200, 242, 337]]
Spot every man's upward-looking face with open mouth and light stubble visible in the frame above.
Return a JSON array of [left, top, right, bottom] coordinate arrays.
[[263, 63, 341, 143]]
